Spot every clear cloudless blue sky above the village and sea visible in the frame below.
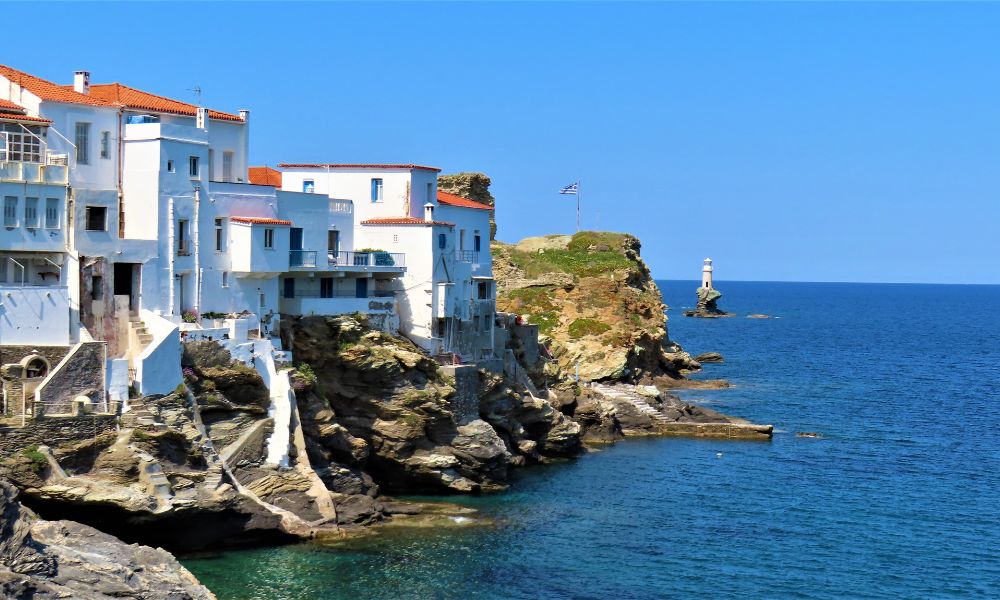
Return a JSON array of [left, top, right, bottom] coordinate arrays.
[[9, 2, 1000, 283]]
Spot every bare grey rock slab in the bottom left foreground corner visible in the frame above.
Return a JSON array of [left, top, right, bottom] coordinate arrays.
[[0, 480, 215, 600]]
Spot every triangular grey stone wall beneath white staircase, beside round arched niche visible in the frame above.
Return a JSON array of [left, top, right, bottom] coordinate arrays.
[[35, 342, 107, 418]]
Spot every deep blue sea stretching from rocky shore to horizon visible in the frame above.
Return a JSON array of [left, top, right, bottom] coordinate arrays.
[[184, 282, 1000, 600]]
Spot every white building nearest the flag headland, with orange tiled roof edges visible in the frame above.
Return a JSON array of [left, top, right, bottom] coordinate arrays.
[[274, 164, 496, 362]]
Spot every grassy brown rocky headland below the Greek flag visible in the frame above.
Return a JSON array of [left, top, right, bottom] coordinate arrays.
[[492, 231, 698, 384]]
